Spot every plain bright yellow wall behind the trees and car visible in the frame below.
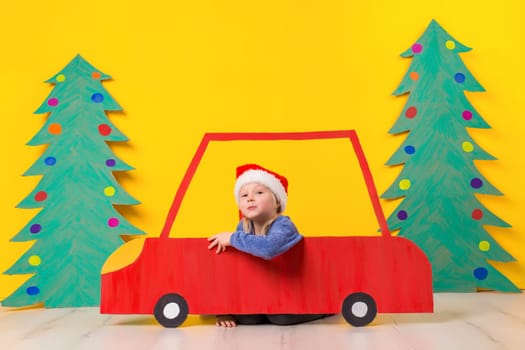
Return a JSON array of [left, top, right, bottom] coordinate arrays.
[[0, 0, 525, 299]]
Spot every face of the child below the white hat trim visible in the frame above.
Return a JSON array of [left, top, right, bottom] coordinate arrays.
[[239, 182, 278, 222]]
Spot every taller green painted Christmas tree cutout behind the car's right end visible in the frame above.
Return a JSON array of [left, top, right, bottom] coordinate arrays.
[[382, 20, 519, 292]]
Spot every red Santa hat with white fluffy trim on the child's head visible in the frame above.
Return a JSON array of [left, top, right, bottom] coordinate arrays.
[[233, 164, 288, 211]]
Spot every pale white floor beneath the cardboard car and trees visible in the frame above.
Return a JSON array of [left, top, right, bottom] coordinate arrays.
[[0, 292, 525, 350]]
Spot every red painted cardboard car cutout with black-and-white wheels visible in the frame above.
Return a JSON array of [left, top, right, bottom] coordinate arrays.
[[100, 130, 433, 327]]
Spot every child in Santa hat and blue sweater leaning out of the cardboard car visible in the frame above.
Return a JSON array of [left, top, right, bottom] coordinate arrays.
[[208, 164, 326, 327]]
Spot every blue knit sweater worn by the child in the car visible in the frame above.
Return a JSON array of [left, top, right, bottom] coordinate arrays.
[[230, 215, 303, 260]]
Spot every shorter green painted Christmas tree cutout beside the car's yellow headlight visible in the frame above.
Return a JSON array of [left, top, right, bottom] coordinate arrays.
[[2, 55, 142, 307]]
